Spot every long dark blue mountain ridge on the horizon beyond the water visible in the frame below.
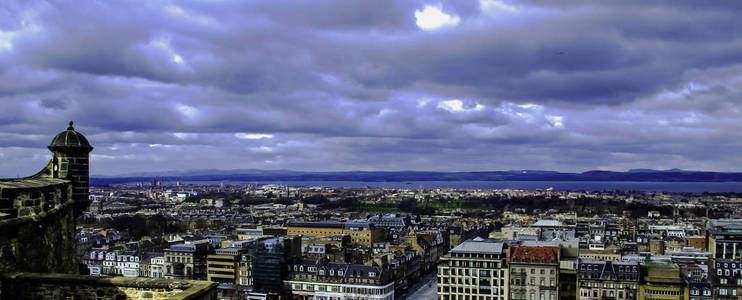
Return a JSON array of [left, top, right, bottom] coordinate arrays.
[[90, 169, 742, 184]]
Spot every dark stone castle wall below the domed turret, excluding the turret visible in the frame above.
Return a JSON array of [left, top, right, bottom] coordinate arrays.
[[0, 179, 79, 274]]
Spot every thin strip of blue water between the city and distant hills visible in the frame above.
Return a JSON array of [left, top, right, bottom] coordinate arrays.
[[166, 181, 742, 193]]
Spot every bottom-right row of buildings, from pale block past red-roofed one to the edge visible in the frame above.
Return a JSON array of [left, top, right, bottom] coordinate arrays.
[[437, 238, 742, 300]]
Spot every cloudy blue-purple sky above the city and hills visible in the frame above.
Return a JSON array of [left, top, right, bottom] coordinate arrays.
[[0, 0, 742, 177]]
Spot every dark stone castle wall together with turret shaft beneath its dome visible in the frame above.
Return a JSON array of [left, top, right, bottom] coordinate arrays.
[[0, 135, 92, 274]]
